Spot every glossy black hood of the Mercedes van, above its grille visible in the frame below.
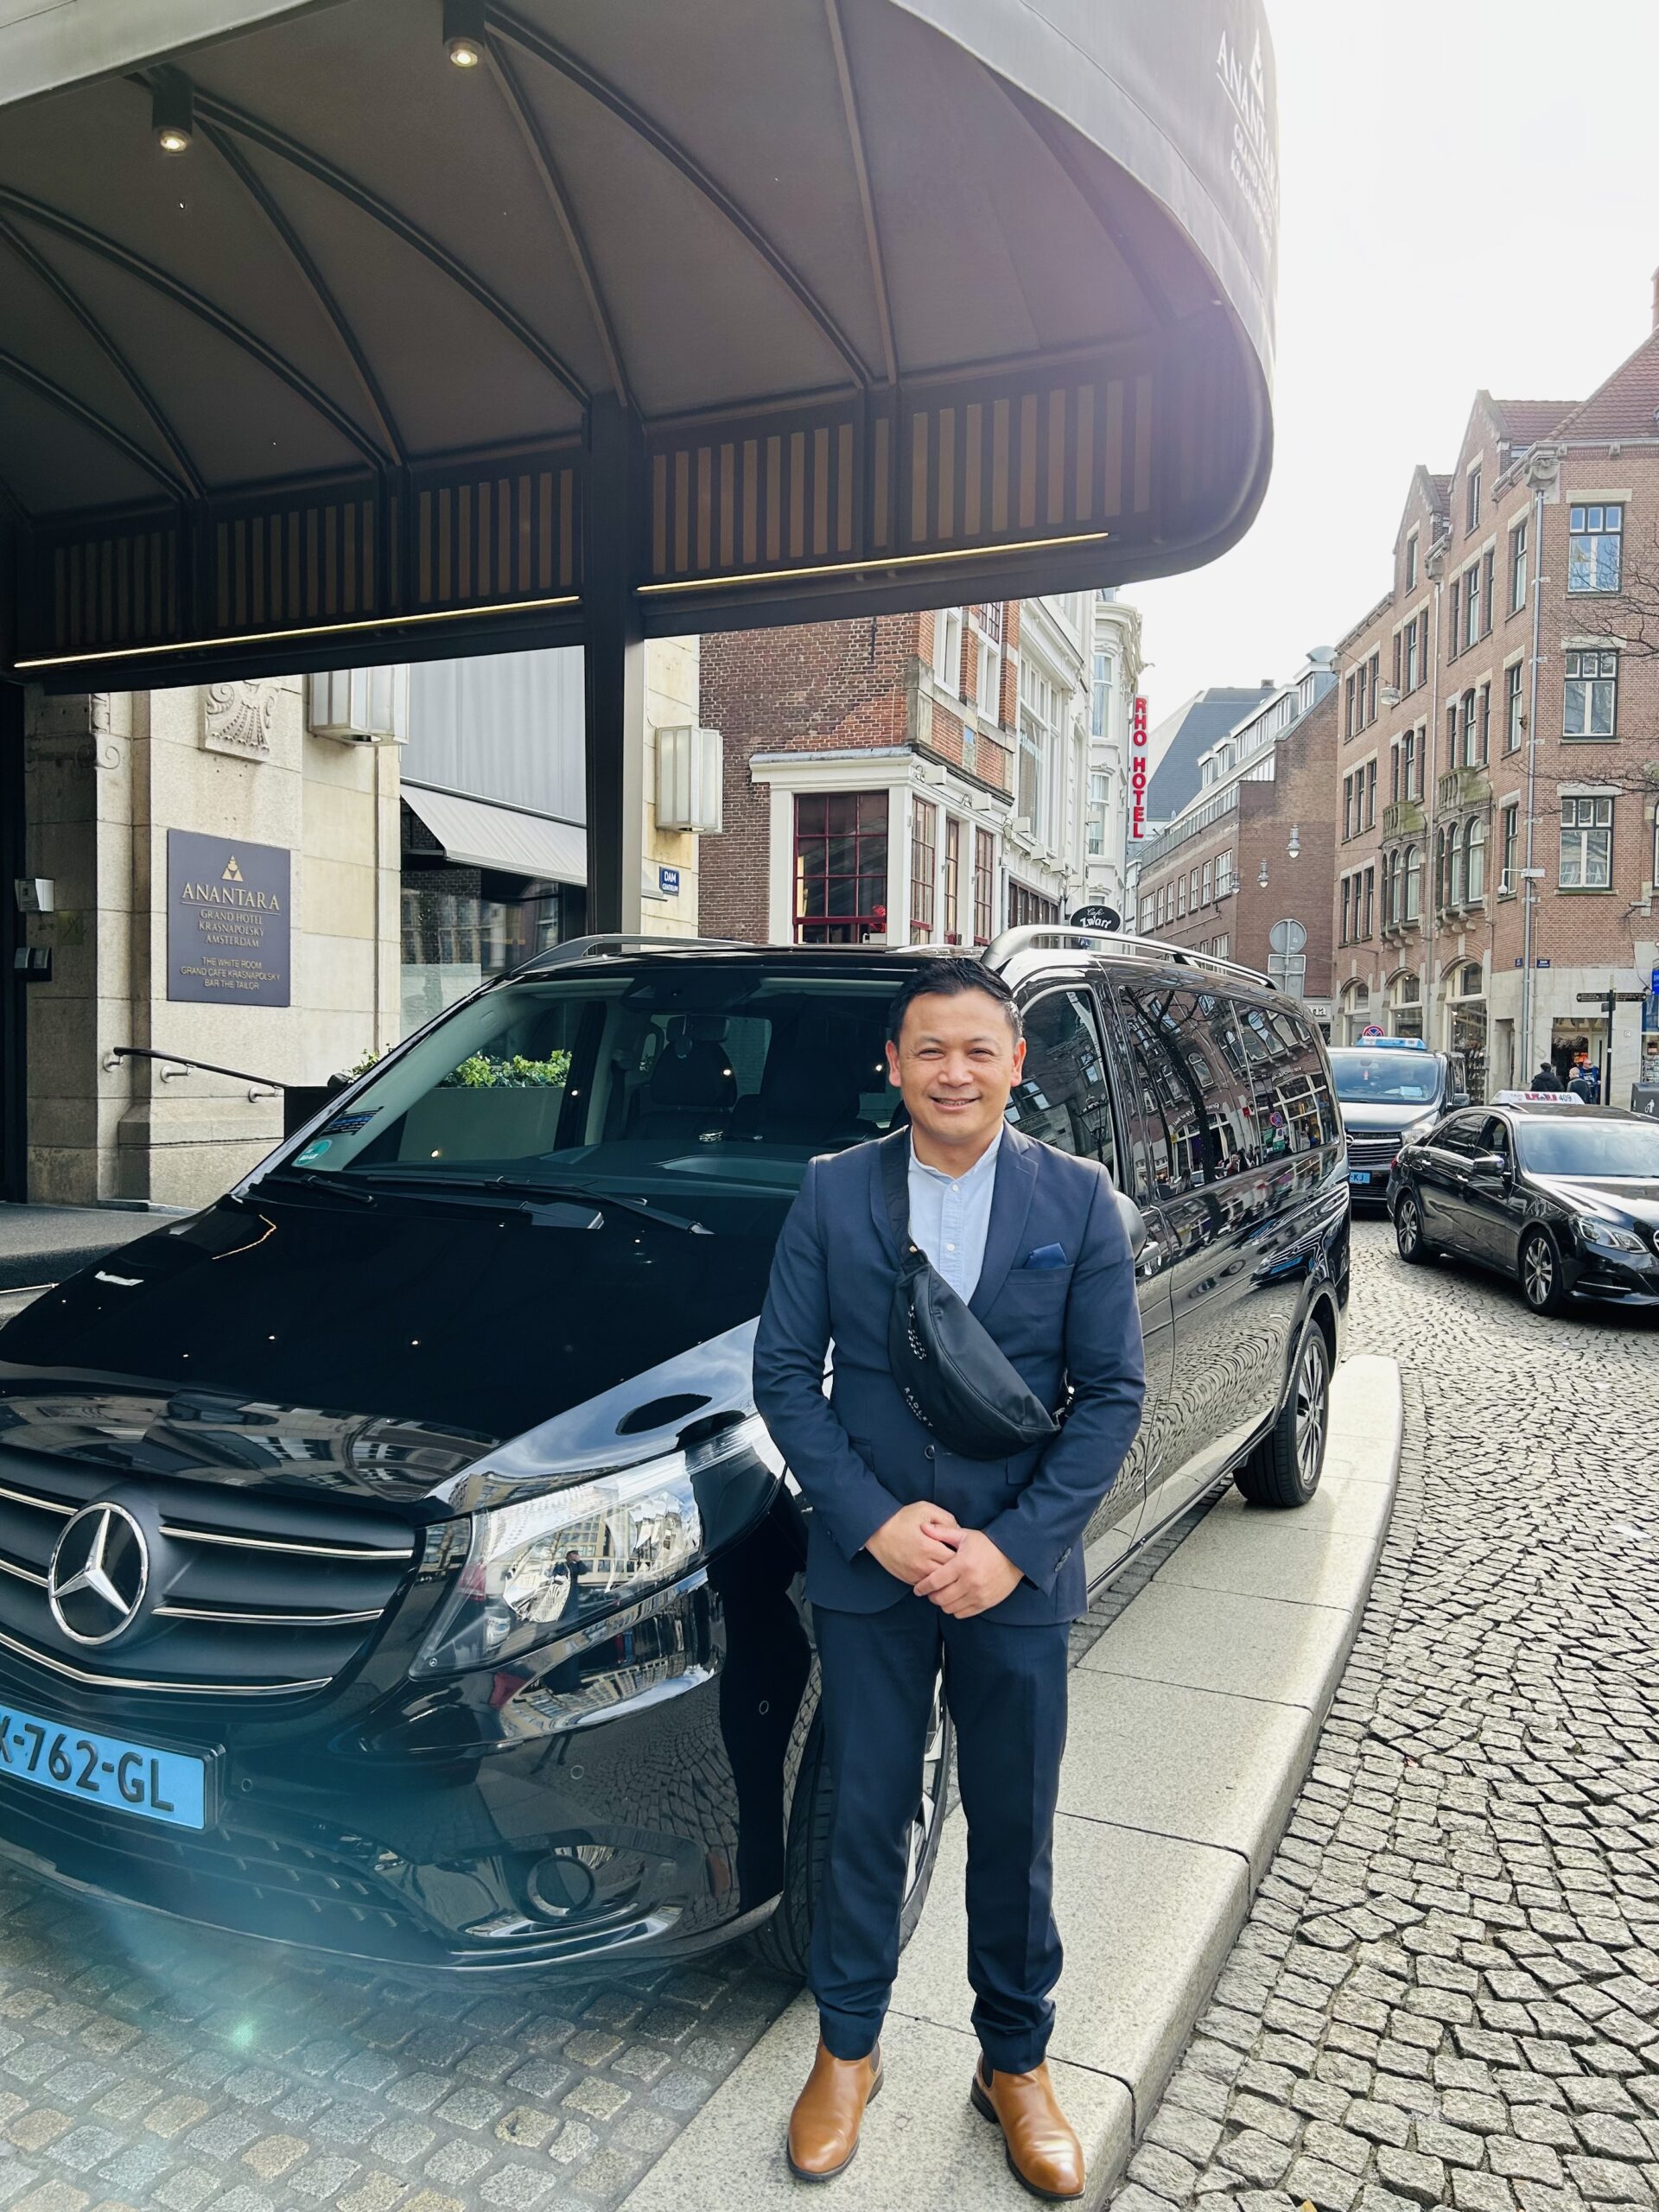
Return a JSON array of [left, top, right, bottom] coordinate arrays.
[[0, 1192, 777, 1513]]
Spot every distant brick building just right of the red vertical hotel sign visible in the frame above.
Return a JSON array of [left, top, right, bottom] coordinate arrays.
[[1135, 652, 1336, 1024]]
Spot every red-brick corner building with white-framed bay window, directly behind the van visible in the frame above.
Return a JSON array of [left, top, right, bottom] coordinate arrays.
[[699, 593, 1110, 947]]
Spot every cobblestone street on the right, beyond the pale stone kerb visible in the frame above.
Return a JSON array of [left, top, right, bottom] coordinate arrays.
[[1113, 1224, 1659, 2212]]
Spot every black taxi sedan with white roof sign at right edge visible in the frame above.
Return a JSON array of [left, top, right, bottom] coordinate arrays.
[[1389, 1093, 1659, 1314]]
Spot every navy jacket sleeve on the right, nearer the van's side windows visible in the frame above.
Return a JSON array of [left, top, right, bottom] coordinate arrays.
[[984, 1174, 1146, 1591]]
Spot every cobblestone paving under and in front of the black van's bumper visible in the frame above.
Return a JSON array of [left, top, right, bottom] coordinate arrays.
[[0, 1299, 1205, 2212]]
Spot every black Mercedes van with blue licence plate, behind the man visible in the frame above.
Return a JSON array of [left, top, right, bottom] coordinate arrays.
[[0, 929, 1350, 1968]]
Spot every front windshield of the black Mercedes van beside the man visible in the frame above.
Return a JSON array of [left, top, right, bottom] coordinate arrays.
[[264, 963, 900, 1224]]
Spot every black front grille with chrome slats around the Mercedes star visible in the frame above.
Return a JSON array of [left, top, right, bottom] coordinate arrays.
[[0, 1451, 416, 1697]]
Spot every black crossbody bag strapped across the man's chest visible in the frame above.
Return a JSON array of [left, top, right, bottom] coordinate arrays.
[[880, 1130, 1059, 1460]]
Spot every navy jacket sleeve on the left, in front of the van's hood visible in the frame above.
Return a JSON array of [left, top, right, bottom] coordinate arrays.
[[754, 1159, 898, 1560]]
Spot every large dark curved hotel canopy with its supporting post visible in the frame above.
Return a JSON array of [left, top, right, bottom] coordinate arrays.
[[0, 0, 1276, 927]]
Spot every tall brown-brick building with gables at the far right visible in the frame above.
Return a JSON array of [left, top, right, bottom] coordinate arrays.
[[1334, 329, 1659, 1103]]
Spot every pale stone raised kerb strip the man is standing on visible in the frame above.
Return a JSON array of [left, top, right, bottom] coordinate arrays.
[[626, 1358, 1400, 2212]]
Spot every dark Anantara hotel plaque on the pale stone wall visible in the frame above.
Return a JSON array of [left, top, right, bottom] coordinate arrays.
[[168, 830, 289, 1007]]
